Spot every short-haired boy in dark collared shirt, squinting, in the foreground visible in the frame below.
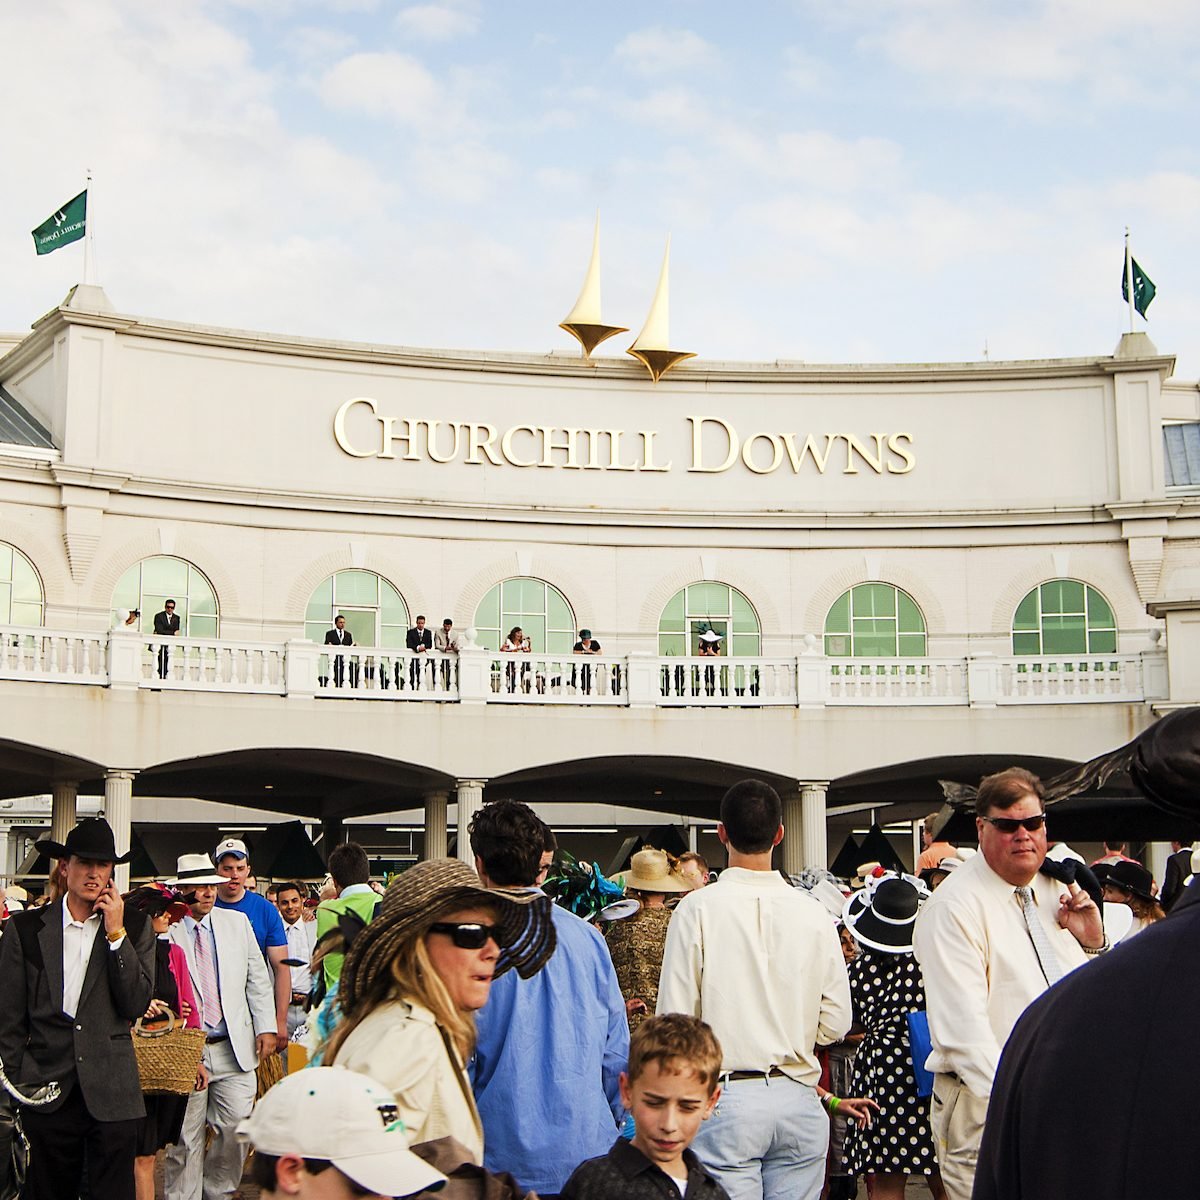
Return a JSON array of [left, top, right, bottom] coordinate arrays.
[[560, 1013, 728, 1200]]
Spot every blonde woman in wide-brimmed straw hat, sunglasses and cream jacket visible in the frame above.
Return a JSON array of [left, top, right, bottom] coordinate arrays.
[[324, 858, 554, 1165]]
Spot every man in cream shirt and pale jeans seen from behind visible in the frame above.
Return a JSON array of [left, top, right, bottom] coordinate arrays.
[[658, 779, 851, 1200]]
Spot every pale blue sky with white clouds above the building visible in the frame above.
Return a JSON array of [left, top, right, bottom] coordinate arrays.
[[0, 0, 1200, 379]]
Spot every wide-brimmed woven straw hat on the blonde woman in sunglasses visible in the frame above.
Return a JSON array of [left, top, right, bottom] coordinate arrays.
[[338, 858, 556, 1012]]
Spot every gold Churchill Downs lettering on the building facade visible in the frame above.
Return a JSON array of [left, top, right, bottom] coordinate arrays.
[[334, 396, 917, 475]]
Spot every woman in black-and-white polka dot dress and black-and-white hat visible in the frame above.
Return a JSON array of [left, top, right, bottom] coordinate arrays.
[[845, 875, 946, 1200]]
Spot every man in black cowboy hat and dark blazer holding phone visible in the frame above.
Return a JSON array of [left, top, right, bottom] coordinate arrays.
[[0, 820, 155, 1200]]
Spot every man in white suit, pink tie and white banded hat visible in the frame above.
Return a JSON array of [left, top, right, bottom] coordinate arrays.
[[166, 854, 275, 1200]]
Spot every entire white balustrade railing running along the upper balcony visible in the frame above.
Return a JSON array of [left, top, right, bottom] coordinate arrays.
[[0, 625, 1168, 709]]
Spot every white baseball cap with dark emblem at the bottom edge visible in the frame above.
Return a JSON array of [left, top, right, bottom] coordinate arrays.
[[238, 1067, 446, 1196]]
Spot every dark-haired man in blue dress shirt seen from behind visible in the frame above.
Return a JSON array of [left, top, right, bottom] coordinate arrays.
[[470, 800, 629, 1200]]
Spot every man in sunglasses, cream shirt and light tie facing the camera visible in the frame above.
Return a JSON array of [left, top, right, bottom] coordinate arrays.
[[913, 767, 1109, 1200]]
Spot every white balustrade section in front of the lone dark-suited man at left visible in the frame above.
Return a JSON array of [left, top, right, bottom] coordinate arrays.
[[138, 634, 287, 696]]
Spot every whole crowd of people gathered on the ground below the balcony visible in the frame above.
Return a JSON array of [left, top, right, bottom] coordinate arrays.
[[0, 710, 1200, 1200]]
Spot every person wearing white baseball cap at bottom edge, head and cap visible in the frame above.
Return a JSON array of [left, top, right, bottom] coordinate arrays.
[[238, 1067, 446, 1200]]
